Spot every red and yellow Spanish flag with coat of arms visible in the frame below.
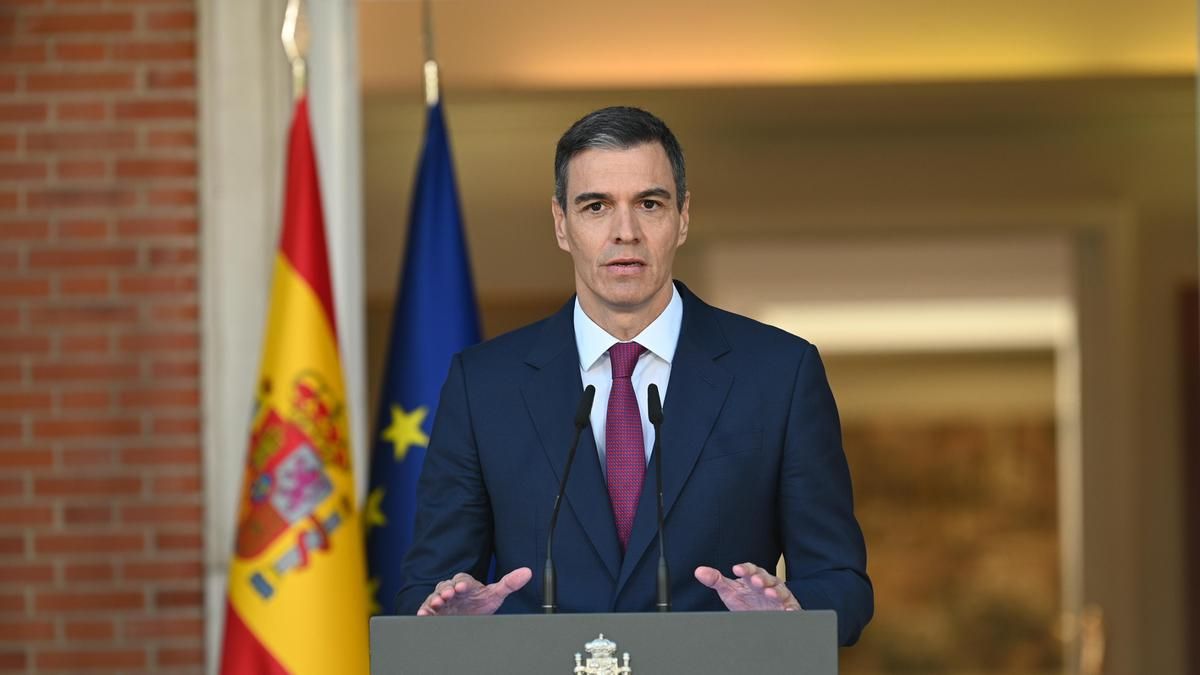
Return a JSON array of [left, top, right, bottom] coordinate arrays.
[[221, 98, 368, 675]]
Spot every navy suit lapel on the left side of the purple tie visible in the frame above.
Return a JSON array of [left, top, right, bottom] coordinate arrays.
[[521, 299, 620, 579]]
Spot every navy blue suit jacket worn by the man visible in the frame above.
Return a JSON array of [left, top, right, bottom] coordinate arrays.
[[398, 283, 874, 644]]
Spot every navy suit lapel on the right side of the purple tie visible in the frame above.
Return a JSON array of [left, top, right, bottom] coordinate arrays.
[[619, 283, 733, 593]]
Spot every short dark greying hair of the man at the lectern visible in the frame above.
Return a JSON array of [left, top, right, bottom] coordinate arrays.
[[554, 106, 688, 210]]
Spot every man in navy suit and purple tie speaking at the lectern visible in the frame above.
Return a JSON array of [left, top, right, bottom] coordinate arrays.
[[398, 103, 874, 644]]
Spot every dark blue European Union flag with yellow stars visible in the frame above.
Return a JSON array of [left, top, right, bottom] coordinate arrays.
[[364, 102, 479, 614]]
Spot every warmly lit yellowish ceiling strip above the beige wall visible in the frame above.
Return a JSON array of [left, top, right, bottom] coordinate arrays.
[[359, 0, 1196, 94]]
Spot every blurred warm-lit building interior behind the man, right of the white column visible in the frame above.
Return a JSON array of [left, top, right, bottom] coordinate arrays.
[[359, 0, 1200, 675]]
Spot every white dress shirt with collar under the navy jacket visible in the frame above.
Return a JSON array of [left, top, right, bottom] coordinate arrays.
[[575, 283, 683, 474]]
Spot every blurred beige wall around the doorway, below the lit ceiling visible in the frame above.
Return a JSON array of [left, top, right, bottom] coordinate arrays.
[[364, 77, 1196, 675]]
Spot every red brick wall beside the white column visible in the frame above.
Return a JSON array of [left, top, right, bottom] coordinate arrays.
[[0, 0, 204, 673]]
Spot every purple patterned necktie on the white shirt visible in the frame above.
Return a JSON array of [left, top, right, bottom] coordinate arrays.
[[605, 342, 646, 550]]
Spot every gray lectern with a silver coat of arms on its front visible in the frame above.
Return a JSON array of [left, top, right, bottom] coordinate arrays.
[[371, 611, 838, 675]]
